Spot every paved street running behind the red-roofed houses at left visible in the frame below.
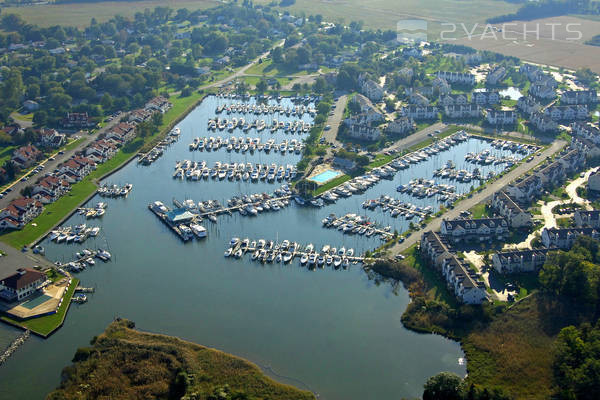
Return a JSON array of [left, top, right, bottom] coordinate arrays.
[[0, 114, 123, 209]]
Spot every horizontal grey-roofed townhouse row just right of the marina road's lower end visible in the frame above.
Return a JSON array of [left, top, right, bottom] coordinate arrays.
[[440, 218, 508, 242]]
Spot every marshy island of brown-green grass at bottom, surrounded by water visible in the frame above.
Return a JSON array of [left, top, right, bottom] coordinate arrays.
[[47, 319, 315, 400]]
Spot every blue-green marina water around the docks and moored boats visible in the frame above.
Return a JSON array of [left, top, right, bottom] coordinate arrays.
[[0, 97, 524, 400]]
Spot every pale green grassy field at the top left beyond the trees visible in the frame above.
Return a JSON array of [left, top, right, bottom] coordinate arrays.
[[2, 0, 218, 28]]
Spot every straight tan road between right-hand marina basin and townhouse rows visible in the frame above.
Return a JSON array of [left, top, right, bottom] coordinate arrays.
[[390, 140, 567, 255]]
